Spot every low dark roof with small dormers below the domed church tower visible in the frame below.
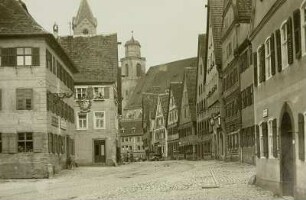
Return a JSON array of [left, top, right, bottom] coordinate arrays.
[[119, 120, 143, 136]]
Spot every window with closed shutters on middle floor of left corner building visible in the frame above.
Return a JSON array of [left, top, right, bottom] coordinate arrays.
[[16, 89, 33, 110]]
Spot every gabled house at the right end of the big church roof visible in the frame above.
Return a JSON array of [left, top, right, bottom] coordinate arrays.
[[178, 67, 198, 160]]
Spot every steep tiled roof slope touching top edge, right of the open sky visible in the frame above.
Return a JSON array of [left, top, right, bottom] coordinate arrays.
[[208, 0, 224, 66]]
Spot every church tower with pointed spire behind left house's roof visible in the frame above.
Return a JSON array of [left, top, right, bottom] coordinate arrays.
[[72, 0, 97, 36]]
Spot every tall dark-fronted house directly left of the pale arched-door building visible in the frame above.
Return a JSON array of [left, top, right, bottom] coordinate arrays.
[[221, 0, 254, 163]]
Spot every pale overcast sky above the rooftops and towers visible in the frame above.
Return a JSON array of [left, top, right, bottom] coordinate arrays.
[[24, 0, 206, 69]]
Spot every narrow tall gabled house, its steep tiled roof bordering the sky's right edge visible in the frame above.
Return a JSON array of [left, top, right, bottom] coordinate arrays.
[[201, 0, 225, 159]]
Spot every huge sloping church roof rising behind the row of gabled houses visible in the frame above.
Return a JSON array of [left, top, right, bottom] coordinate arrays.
[[125, 58, 197, 109]]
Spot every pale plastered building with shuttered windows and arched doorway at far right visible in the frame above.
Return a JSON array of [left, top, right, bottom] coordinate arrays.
[[250, 0, 306, 200]]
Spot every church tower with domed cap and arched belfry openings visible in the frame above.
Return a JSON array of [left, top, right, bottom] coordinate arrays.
[[121, 36, 146, 110]]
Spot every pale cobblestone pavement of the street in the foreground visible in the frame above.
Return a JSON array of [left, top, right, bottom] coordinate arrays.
[[0, 161, 292, 200]]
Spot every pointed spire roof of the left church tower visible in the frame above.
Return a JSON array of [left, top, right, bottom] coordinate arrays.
[[73, 0, 97, 27]]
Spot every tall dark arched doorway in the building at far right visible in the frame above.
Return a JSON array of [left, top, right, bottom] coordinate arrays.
[[280, 112, 294, 196]]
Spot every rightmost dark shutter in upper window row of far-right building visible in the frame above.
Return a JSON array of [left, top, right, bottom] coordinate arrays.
[[293, 9, 302, 59]]
